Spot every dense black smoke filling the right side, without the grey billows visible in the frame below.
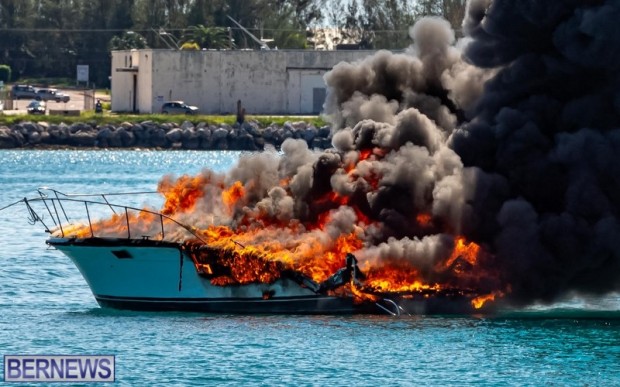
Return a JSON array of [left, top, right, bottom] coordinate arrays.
[[451, 0, 620, 300]]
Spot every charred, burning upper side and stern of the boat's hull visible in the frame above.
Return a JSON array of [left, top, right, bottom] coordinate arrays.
[[183, 240, 494, 314]]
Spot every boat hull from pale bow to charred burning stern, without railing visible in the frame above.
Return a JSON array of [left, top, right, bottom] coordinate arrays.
[[47, 237, 484, 316]]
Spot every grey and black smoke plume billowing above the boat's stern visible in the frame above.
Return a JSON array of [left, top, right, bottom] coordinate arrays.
[[325, 0, 620, 302]]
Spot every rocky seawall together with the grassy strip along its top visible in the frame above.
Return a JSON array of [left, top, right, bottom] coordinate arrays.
[[0, 113, 332, 151]]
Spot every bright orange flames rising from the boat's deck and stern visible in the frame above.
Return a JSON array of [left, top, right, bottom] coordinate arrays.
[[55, 146, 501, 308]]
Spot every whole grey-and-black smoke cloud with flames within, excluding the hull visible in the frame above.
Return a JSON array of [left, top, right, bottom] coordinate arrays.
[[93, 0, 620, 310]]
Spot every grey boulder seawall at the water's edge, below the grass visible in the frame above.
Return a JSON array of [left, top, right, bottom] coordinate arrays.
[[0, 121, 332, 151]]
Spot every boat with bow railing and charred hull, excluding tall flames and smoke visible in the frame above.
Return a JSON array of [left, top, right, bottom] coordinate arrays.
[[6, 189, 494, 315]]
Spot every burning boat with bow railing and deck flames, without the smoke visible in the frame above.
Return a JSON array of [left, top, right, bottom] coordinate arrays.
[[2, 186, 499, 315]]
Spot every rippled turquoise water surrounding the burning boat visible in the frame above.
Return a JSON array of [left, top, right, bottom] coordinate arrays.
[[0, 150, 620, 386]]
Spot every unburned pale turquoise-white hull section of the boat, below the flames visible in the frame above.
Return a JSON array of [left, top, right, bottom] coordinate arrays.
[[47, 238, 368, 314]]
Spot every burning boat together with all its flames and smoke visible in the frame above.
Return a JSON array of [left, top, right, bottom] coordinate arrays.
[[3, 0, 620, 314]]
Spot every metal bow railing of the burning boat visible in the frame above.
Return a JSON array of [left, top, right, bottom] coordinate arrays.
[[0, 187, 206, 244]]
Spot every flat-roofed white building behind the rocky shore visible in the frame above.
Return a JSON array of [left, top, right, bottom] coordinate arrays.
[[111, 49, 374, 114]]
